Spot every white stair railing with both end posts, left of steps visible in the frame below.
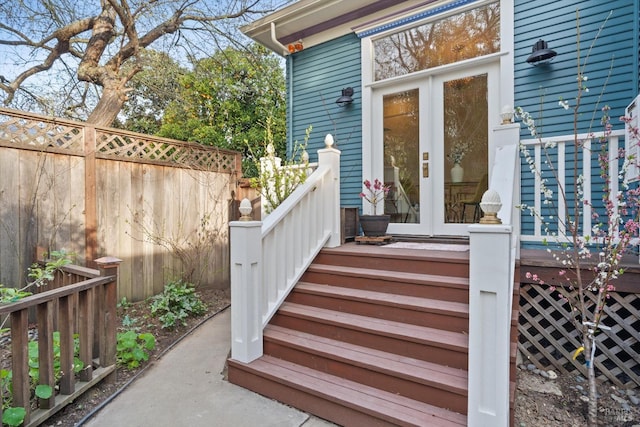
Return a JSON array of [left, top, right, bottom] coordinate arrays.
[[230, 135, 340, 363]]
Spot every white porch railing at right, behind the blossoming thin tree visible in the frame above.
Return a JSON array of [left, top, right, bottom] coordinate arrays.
[[520, 130, 624, 242]]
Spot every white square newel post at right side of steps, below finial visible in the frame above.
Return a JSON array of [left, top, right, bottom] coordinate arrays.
[[467, 224, 513, 427]]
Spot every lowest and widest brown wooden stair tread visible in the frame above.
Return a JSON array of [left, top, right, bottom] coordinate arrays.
[[233, 355, 467, 427]]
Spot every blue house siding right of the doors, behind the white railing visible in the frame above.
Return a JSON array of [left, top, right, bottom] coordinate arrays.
[[514, 0, 639, 241]]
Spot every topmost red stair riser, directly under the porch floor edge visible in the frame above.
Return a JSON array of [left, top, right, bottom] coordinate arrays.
[[314, 252, 469, 277]]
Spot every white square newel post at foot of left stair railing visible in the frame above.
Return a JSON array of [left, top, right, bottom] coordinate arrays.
[[229, 221, 262, 363]]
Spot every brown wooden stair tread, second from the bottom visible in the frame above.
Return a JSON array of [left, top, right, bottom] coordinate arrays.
[[264, 325, 468, 396]]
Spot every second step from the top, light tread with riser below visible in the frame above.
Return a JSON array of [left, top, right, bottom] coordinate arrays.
[[287, 282, 469, 333]]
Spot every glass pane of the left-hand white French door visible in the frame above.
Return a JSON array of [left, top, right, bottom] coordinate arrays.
[[382, 89, 420, 224]]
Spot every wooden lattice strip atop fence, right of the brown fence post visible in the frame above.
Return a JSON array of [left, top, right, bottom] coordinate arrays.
[[96, 131, 237, 173]]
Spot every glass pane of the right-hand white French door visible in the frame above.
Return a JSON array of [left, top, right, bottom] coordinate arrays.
[[440, 74, 489, 223]]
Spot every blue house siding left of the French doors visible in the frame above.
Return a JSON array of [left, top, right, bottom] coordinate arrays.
[[287, 34, 362, 206]]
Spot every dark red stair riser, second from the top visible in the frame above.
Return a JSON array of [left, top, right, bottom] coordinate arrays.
[[301, 267, 469, 304]]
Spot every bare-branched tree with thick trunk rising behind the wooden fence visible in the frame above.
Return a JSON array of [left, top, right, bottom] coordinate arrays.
[[0, 0, 284, 125]]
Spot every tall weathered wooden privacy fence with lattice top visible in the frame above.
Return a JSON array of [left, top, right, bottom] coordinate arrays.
[[0, 108, 241, 300]]
